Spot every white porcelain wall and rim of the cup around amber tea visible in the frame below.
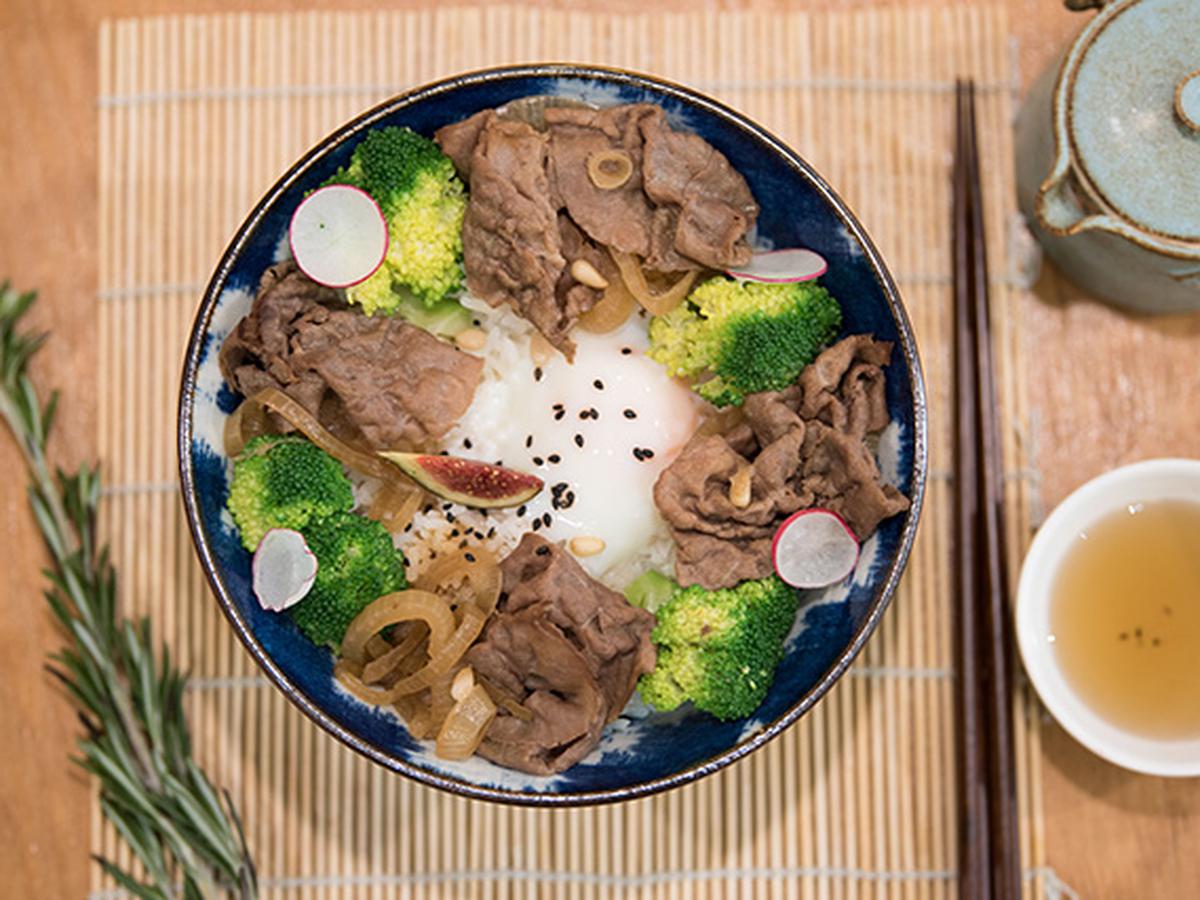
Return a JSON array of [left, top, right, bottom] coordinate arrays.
[[1016, 460, 1200, 776]]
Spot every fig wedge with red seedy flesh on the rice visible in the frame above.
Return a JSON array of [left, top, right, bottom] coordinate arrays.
[[379, 450, 544, 509]]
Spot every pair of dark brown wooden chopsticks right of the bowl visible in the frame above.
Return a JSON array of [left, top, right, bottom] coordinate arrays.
[[953, 82, 1021, 900]]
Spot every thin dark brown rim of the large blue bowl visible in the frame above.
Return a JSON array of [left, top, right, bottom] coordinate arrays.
[[178, 62, 929, 806]]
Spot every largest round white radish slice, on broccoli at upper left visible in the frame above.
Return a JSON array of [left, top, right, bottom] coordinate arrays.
[[288, 185, 388, 288]]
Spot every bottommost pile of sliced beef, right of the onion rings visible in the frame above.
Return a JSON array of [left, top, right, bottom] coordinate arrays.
[[467, 533, 655, 774]]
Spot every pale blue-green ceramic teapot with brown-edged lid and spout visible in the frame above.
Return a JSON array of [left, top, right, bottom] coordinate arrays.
[[1016, 0, 1200, 312]]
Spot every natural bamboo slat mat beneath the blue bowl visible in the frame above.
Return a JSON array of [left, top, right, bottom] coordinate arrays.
[[92, 7, 1054, 900]]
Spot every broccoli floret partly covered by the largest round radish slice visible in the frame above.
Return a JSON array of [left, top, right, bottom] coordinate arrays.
[[326, 127, 467, 316]]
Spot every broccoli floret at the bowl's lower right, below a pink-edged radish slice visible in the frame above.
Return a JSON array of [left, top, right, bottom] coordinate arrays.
[[638, 576, 798, 721]]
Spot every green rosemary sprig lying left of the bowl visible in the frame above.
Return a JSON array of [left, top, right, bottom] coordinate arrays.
[[0, 281, 258, 900]]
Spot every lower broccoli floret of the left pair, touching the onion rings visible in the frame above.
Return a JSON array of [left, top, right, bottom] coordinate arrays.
[[290, 512, 408, 650]]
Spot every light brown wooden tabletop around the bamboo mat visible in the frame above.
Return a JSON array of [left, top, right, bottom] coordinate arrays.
[[0, 0, 1200, 899]]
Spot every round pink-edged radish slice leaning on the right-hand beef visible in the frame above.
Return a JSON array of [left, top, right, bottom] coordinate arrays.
[[770, 509, 858, 588]]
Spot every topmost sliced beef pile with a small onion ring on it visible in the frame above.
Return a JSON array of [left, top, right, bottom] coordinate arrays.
[[434, 103, 758, 348]]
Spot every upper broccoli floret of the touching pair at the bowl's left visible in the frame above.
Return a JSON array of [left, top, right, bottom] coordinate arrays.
[[226, 434, 354, 551]]
